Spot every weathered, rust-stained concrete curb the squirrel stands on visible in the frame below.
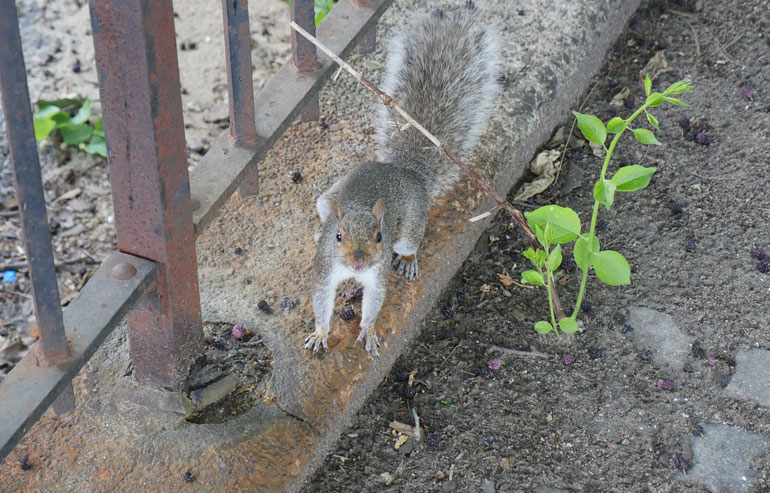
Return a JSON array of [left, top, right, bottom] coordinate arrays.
[[0, 0, 639, 491]]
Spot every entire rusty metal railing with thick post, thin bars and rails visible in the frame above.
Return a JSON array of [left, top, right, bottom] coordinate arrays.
[[0, 0, 392, 461]]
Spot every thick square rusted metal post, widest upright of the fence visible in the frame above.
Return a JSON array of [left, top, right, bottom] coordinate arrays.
[[90, 0, 202, 390]]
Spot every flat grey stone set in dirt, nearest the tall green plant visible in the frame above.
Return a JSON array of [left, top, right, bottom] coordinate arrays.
[[628, 306, 693, 371]]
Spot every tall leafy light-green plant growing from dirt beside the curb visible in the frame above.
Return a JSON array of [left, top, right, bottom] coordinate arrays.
[[521, 76, 693, 338]]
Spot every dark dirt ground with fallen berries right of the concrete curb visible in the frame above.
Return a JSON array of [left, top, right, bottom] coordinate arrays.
[[304, 0, 770, 492]]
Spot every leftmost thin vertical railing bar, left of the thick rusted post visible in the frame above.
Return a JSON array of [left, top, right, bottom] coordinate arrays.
[[0, 0, 75, 413]]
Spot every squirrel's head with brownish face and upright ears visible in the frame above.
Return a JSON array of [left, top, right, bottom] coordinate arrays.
[[329, 198, 385, 272]]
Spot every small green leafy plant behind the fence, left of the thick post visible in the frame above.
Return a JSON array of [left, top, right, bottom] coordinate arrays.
[[32, 98, 107, 157]]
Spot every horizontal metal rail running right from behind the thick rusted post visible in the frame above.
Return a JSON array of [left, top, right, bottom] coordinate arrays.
[[190, 0, 393, 234]]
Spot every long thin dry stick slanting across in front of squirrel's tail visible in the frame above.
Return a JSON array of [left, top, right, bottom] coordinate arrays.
[[290, 22, 565, 320]]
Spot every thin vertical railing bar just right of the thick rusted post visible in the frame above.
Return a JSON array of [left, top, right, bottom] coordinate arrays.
[[222, 0, 257, 146]]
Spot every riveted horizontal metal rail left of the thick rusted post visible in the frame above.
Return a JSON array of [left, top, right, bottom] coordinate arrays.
[[0, 252, 158, 462]]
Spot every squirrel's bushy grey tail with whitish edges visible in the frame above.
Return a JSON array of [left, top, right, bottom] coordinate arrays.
[[377, 1, 500, 197]]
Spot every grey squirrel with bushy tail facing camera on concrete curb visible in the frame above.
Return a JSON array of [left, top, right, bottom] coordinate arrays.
[[305, 1, 499, 356]]
